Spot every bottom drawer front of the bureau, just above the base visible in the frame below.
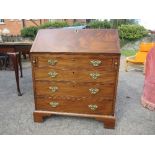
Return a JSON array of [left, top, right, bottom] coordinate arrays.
[[36, 98, 113, 115]]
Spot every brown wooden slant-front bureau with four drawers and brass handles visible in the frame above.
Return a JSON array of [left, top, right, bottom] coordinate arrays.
[[30, 29, 120, 128]]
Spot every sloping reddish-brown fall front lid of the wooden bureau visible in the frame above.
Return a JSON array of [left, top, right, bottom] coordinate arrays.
[[31, 29, 120, 53]]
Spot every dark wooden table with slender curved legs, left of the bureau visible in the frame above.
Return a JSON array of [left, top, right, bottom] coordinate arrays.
[[0, 42, 32, 96]]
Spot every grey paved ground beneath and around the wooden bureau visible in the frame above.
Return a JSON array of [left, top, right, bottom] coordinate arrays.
[[0, 57, 155, 135]]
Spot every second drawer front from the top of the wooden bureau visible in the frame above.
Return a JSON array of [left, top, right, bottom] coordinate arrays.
[[35, 68, 116, 83]]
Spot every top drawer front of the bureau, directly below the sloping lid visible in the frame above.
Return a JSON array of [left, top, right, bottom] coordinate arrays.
[[33, 55, 117, 70]]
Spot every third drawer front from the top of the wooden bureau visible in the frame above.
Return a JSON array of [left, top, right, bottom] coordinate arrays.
[[35, 81, 114, 99]]
